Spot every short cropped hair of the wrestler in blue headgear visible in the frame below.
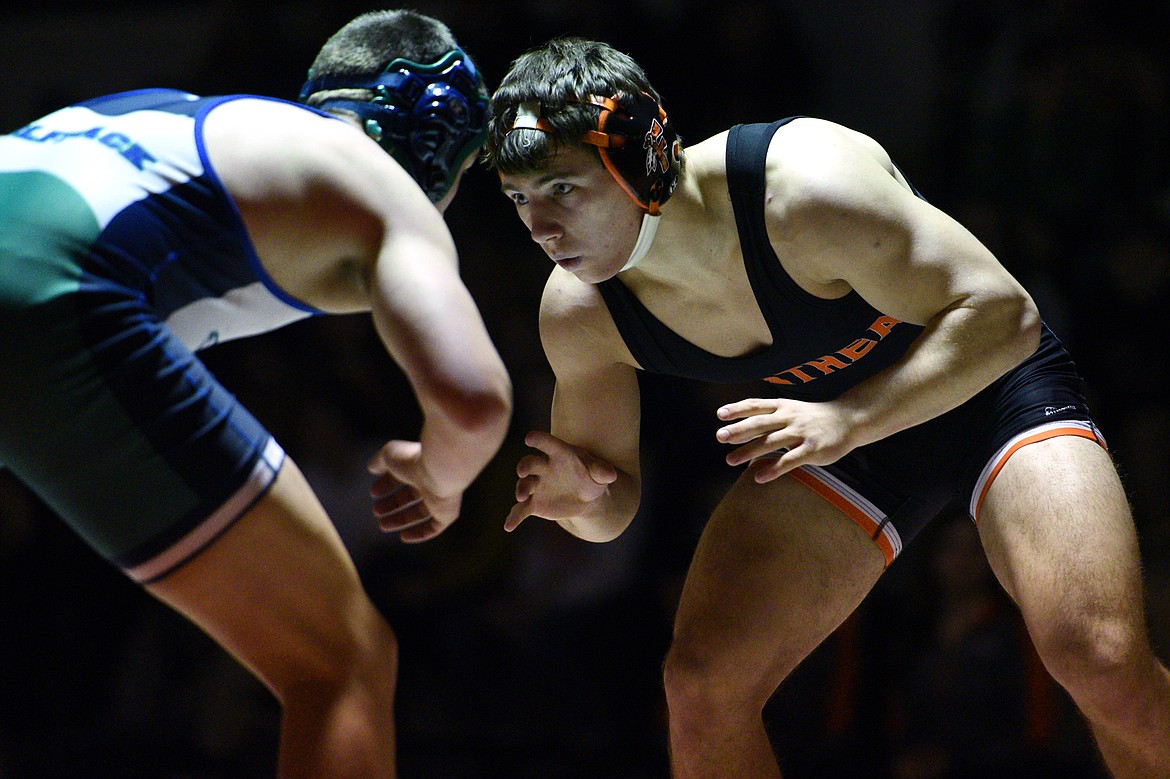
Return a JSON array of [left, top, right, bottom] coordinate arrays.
[[304, 11, 459, 105]]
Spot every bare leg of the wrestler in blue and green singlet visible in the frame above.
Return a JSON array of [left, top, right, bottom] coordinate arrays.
[[149, 459, 398, 779]]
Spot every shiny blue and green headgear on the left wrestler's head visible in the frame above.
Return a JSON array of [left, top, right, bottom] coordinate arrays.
[[301, 48, 488, 202]]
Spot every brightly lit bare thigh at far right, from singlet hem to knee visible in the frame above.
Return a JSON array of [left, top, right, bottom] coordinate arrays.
[[978, 436, 1142, 629]]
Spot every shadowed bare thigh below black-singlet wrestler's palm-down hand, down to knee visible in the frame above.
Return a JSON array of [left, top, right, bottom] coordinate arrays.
[[675, 474, 885, 682]]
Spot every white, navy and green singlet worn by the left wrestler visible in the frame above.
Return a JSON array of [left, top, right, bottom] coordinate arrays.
[[0, 89, 325, 581]]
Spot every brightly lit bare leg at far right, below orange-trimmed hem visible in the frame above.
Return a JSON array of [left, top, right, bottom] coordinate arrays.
[[978, 436, 1170, 778]]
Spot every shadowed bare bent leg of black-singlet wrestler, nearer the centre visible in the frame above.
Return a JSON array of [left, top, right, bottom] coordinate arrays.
[[665, 474, 885, 779]]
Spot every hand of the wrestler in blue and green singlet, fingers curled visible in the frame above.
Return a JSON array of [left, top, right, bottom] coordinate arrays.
[[369, 441, 462, 544]]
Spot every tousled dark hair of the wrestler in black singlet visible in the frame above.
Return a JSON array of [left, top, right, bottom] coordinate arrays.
[[483, 37, 661, 173]]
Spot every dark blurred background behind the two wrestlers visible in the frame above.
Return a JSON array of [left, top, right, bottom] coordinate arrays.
[[0, 0, 1170, 779]]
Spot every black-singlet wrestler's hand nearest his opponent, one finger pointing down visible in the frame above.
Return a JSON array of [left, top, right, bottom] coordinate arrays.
[[504, 430, 618, 532]]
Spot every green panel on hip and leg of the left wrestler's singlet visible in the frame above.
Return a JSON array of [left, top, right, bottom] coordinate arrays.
[[0, 172, 198, 558]]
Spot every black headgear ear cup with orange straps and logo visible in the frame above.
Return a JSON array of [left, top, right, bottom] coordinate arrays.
[[583, 92, 682, 216]]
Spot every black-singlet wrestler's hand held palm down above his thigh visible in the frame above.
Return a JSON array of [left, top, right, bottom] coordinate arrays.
[[715, 398, 853, 484]]
